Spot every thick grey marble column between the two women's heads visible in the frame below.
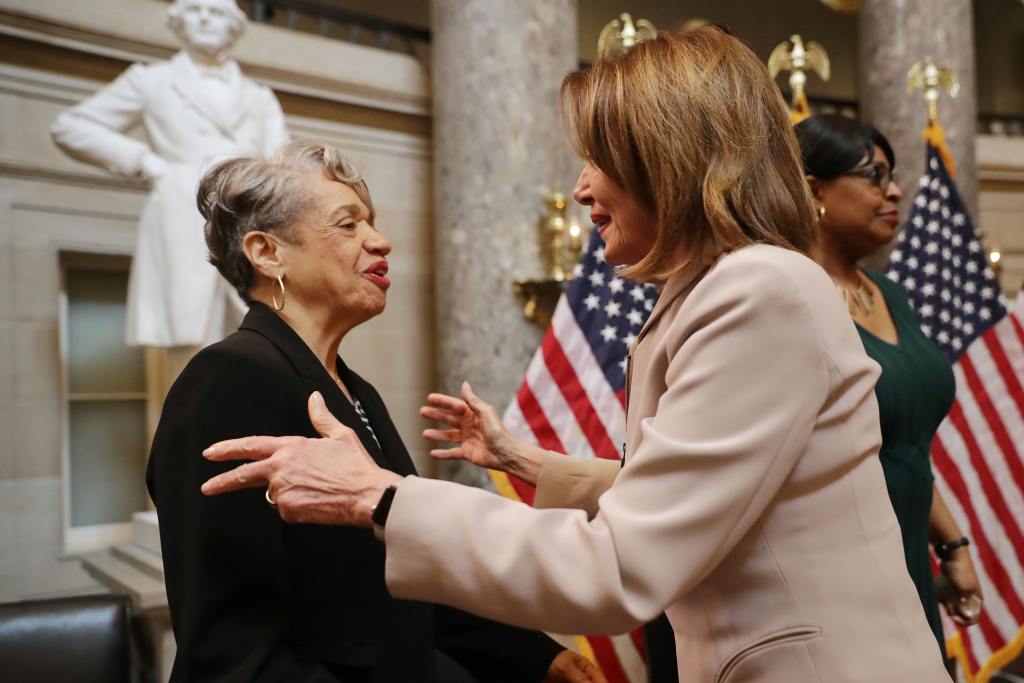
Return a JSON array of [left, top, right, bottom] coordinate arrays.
[[431, 0, 581, 481]]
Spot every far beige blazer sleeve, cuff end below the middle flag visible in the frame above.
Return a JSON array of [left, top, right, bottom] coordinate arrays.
[[534, 452, 622, 518]]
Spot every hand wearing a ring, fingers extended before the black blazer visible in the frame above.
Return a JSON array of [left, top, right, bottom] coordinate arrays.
[[203, 392, 401, 526]]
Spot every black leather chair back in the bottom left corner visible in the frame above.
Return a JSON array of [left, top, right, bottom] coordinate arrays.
[[0, 595, 133, 683]]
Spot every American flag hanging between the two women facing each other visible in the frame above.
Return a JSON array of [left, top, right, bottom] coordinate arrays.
[[492, 230, 657, 683]]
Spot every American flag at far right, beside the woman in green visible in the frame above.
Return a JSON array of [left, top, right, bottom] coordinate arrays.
[[888, 144, 1024, 683]]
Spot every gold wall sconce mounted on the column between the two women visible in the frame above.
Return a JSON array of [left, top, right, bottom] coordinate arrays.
[[512, 193, 584, 330]]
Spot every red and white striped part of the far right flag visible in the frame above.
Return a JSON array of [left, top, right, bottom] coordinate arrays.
[[932, 294, 1024, 683]]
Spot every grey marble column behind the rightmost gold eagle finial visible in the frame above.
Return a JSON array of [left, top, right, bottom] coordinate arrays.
[[858, 0, 978, 235]]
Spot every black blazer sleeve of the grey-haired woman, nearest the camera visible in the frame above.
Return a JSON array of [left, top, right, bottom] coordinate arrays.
[[148, 347, 338, 683]]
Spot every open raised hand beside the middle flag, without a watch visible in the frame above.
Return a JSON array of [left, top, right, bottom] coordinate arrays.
[[420, 382, 544, 484]]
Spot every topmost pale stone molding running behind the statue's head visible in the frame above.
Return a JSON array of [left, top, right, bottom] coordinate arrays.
[[0, 0, 430, 117]]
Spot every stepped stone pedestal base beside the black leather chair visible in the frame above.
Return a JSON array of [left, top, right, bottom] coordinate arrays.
[[81, 512, 177, 683]]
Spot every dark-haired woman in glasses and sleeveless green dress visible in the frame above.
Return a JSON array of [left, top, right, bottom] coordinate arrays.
[[796, 115, 981, 657]]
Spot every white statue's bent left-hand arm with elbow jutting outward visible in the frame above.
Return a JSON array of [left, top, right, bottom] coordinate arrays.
[[50, 65, 150, 176]]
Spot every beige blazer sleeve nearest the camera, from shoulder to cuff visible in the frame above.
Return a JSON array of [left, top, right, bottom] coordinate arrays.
[[385, 260, 828, 634]]
